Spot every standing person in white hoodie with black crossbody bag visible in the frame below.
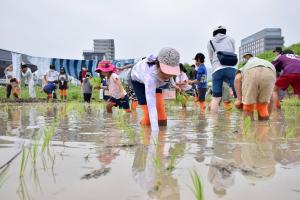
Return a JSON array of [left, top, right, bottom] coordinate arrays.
[[207, 26, 237, 112]]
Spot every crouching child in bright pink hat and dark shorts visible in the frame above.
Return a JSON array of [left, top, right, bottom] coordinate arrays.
[[97, 61, 130, 113]]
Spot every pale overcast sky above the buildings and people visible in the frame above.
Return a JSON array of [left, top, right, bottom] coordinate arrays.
[[0, 0, 300, 63]]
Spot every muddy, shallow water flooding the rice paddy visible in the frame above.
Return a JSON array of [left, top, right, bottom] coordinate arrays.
[[0, 103, 300, 200]]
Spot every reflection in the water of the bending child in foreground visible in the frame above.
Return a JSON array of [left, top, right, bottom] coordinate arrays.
[[132, 130, 180, 200]]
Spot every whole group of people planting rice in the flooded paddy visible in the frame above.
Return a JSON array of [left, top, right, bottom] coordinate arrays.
[[2, 26, 300, 130]]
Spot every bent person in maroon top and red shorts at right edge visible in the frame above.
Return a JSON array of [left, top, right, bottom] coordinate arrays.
[[272, 49, 300, 103]]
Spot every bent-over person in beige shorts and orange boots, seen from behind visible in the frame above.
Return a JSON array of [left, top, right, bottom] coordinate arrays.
[[234, 53, 276, 120]]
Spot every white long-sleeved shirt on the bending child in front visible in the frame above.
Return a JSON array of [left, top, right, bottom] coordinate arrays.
[[131, 56, 166, 131]]
